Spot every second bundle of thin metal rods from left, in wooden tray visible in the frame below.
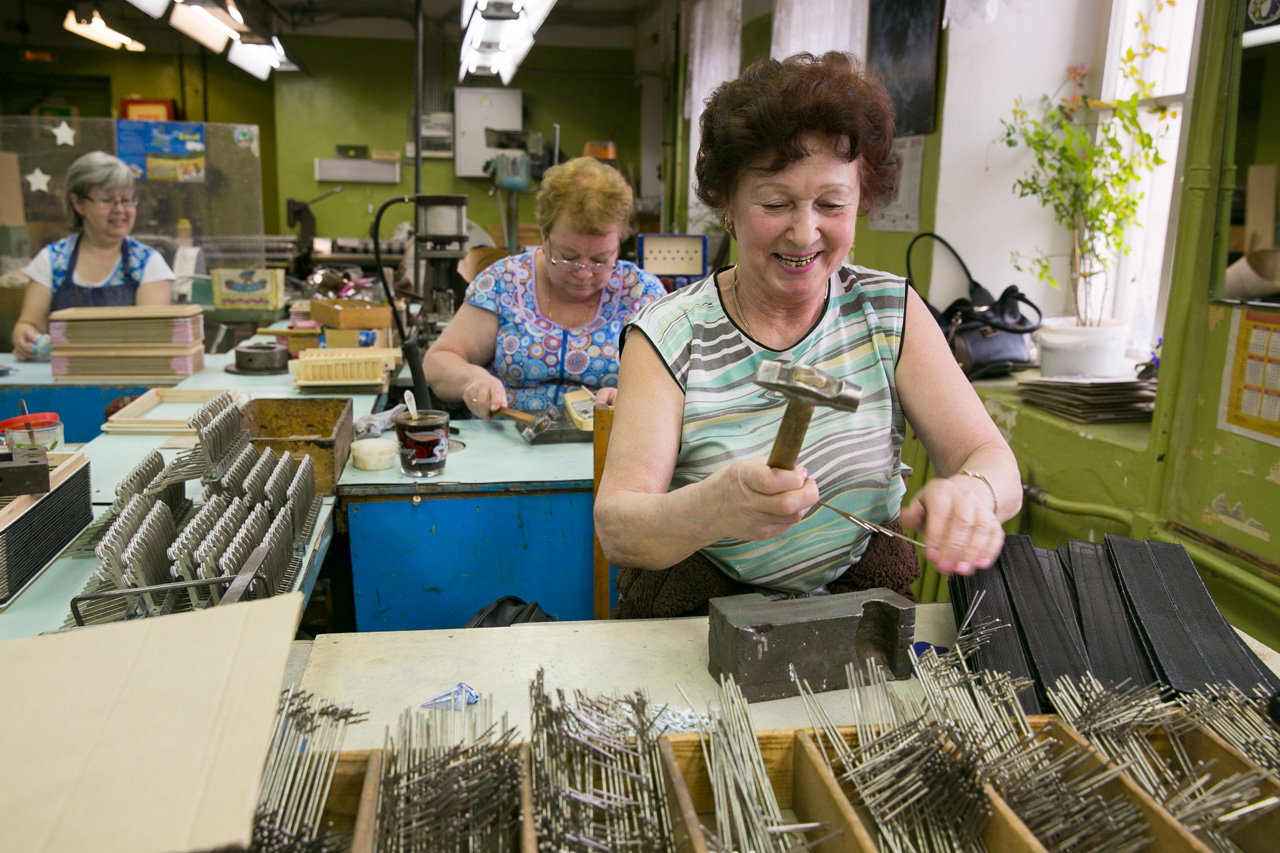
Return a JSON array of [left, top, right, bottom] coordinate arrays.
[[376, 697, 521, 853]]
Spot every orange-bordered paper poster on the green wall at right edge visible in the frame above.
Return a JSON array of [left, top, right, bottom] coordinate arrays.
[[1217, 309, 1280, 447]]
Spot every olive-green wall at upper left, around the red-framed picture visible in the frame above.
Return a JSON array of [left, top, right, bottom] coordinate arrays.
[[0, 45, 279, 233]]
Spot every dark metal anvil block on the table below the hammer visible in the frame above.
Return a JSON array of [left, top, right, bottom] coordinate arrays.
[[707, 589, 915, 702]]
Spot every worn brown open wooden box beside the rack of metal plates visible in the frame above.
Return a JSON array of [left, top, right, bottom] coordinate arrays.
[[241, 397, 355, 494]]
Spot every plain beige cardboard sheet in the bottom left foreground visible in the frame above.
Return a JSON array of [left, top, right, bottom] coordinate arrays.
[[0, 593, 302, 853]]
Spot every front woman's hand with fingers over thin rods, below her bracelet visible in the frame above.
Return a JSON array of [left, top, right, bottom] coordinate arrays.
[[901, 475, 1005, 575]]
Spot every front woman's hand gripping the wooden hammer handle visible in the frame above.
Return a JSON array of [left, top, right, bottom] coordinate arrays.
[[703, 456, 818, 542]]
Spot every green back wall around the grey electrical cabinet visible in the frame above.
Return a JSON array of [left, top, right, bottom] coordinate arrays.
[[275, 37, 640, 237]]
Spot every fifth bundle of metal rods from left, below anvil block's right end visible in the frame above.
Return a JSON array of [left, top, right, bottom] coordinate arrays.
[[799, 661, 991, 853]]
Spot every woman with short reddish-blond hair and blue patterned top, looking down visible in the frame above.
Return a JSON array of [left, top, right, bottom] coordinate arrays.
[[422, 158, 666, 420]]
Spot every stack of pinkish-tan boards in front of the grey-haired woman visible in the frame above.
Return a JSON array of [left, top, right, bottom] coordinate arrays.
[[49, 305, 205, 383]]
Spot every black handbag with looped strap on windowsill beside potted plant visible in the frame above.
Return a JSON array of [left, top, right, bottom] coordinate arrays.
[[906, 231, 1043, 379]]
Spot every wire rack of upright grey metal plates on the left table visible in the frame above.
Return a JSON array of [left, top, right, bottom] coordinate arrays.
[[64, 393, 323, 628]]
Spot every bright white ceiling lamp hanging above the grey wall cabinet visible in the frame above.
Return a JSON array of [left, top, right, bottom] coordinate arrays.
[[458, 0, 556, 86]]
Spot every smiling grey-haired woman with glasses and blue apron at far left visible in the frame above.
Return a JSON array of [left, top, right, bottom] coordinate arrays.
[[13, 151, 173, 360]]
